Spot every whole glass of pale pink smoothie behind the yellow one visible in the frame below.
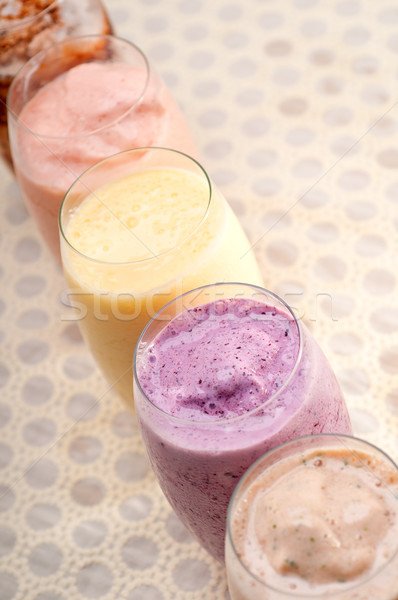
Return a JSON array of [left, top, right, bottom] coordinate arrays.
[[8, 35, 196, 259]]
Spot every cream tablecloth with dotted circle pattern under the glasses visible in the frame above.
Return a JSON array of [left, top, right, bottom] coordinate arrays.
[[0, 0, 398, 600]]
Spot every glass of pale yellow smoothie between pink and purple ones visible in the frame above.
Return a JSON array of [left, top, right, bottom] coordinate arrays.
[[59, 147, 262, 406]]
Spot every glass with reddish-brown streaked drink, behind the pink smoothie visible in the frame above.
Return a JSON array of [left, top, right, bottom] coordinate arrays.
[[0, 0, 112, 166]]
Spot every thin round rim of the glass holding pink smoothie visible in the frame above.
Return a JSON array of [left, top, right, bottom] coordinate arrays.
[[6, 33, 152, 140]]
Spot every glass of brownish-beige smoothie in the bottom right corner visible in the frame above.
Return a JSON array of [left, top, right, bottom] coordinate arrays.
[[225, 434, 398, 600]]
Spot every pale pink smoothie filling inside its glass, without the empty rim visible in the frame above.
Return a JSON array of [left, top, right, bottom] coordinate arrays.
[[10, 57, 197, 257]]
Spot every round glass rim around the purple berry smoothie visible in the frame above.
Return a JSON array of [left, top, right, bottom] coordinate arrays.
[[133, 281, 303, 428]]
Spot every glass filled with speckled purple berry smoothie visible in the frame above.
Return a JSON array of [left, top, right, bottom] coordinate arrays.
[[134, 283, 352, 562]]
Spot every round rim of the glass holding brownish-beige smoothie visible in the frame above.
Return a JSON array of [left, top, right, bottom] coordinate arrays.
[[226, 433, 398, 600]]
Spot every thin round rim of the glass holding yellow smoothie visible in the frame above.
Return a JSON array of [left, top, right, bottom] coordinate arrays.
[[58, 146, 213, 267]]
